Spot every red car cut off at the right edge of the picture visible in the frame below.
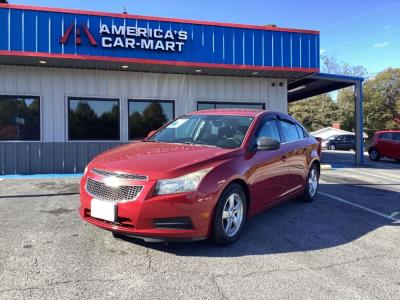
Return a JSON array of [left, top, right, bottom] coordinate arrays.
[[368, 130, 400, 161]]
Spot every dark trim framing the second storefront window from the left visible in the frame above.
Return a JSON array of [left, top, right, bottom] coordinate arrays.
[[65, 95, 123, 142]]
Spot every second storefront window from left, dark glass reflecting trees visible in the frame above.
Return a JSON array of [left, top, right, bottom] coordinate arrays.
[[68, 98, 120, 140]]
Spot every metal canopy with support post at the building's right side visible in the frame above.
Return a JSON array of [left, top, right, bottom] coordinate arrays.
[[288, 73, 364, 165]]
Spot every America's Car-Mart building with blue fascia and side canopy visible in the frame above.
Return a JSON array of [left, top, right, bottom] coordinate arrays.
[[0, 4, 362, 174]]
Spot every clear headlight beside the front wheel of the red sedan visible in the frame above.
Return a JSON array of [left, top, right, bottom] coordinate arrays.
[[155, 168, 211, 195]]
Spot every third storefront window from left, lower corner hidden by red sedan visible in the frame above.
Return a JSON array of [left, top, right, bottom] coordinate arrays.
[[128, 100, 175, 140]]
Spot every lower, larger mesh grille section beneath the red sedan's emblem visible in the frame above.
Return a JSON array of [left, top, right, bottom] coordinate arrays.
[[86, 178, 143, 201]]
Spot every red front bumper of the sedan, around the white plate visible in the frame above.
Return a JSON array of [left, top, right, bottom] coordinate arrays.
[[80, 176, 214, 241]]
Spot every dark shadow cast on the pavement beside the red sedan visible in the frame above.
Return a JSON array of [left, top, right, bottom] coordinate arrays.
[[117, 185, 400, 257]]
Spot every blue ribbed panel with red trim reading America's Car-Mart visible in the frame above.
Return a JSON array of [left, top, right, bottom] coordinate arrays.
[[0, 5, 319, 71]]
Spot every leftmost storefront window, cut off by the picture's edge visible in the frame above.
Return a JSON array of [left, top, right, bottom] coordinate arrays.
[[0, 95, 40, 141]]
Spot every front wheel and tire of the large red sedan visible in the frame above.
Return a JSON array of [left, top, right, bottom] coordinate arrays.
[[210, 183, 247, 246]]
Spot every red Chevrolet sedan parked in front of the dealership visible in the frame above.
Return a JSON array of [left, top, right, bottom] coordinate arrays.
[[80, 109, 320, 245]]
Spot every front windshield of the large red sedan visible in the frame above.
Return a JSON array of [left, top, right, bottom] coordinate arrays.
[[145, 115, 253, 148]]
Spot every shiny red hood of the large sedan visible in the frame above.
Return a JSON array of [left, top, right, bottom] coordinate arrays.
[[90, 142, 241, 180]]
